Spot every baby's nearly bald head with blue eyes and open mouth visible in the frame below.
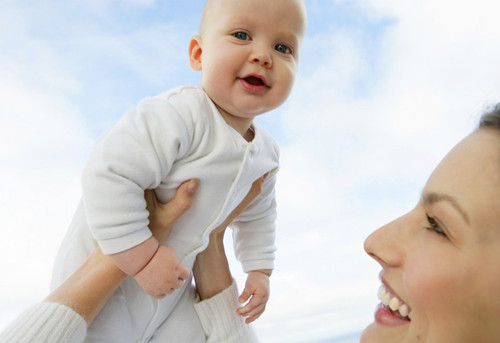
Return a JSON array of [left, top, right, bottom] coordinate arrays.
[[189, 0, 307, 130]]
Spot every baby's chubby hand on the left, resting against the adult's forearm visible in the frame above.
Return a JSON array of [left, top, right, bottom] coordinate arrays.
[[134, 245, 189, 299]]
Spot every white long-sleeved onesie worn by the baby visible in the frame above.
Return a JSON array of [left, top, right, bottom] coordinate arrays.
[[52, 86, 279, 342]]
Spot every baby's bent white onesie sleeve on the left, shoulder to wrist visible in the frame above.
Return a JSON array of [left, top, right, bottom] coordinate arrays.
[[82, 97, 193, 254]]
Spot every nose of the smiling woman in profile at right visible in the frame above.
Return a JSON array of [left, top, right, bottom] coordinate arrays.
[[364, 217, 407, 267]]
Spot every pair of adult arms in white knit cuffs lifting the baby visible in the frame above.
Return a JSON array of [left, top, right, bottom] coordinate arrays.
[[0, 175, 266, 343]]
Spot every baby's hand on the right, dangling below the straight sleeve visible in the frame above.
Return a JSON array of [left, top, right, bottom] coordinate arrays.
[[237, 270, 270, 324]]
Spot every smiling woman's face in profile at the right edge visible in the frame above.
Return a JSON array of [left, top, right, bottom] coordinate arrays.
[[361, 129, 500, 343]]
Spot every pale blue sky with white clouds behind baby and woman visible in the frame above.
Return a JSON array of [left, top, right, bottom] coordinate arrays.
[[0, 0, 500, 343]]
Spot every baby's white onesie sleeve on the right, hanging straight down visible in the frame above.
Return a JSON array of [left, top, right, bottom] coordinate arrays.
[[231, 171, 277, 273]]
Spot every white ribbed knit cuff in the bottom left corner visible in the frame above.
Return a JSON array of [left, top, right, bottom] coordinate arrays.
[[0, 302, 87, 343]]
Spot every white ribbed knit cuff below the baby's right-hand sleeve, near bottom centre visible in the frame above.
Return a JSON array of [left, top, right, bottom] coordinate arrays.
[[194, 280, 258, 343]]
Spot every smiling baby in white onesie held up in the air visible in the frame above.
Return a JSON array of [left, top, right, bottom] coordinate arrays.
[[53, 0, 306, 342]]
